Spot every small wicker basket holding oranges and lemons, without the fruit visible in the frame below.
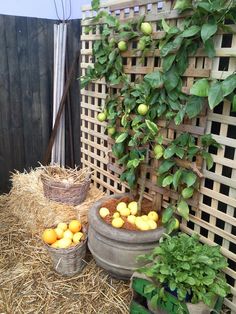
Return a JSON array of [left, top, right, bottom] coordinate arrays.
[[46, 229, 87, 277]]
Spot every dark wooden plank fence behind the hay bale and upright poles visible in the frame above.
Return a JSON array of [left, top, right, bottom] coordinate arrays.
[[0, 15, 80, 192]]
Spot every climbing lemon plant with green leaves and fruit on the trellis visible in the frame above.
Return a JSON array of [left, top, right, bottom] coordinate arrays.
[[81, 0, 236, 233]]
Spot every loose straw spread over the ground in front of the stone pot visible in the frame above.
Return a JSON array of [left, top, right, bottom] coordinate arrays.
[[0, 197, 131, 314]]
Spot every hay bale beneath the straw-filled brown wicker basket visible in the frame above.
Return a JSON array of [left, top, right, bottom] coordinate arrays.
[[6, 167, 103, 233]]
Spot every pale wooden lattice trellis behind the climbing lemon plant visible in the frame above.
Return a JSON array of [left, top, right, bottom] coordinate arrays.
[[81, 0, 236, 313]]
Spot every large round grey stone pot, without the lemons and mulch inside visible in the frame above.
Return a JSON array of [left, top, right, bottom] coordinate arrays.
[[88, 194, 165, 279]]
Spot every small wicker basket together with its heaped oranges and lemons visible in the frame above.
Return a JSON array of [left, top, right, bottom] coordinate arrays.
[[42, 219, 87, 276]]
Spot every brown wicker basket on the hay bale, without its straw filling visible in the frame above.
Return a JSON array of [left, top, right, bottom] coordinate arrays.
[[41, 174, 91, 205]]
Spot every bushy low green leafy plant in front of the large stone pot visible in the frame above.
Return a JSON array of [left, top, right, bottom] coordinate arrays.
[[138, 233, 229, 314]]
